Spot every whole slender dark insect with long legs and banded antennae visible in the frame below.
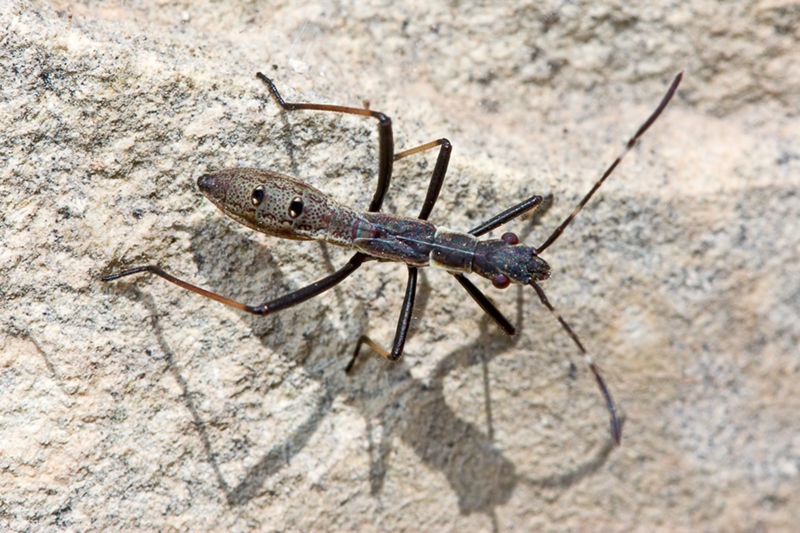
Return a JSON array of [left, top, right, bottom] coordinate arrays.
[[102, 72, 683, 445]]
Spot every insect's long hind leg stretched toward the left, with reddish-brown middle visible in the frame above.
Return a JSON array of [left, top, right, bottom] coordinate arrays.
[[100, 253, 367, 315]]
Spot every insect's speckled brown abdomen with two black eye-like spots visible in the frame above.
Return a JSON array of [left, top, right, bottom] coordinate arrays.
[[197, 168, 344, 240]]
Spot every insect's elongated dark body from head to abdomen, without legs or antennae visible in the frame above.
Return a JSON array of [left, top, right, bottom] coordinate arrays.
[[197, 168, 550, 285]]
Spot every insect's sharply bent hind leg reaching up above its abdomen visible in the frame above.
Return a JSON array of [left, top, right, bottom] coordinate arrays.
[[256, 72, 394, 212]]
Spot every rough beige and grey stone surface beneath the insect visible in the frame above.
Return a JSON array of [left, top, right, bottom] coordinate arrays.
[[0, 0, 800, 531]]
